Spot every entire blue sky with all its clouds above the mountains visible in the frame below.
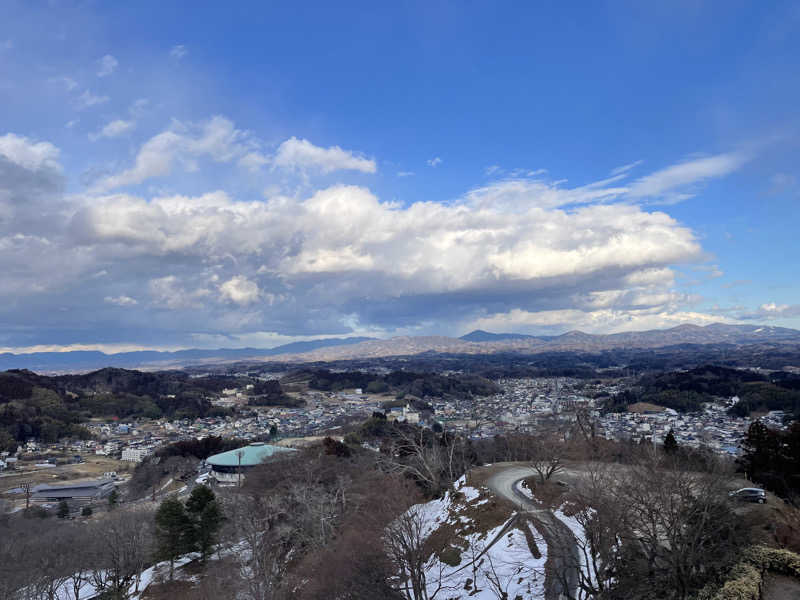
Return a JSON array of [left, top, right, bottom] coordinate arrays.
[[0, 0, 800, 352]]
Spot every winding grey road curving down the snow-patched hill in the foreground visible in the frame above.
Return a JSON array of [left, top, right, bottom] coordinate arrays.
[[487, 466, 580, 600]]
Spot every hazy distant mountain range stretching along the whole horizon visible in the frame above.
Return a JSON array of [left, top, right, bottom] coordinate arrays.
[[0, 323, 800, 373]]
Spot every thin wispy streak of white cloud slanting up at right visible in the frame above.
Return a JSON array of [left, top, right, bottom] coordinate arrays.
[[628, 152, 749, 201]]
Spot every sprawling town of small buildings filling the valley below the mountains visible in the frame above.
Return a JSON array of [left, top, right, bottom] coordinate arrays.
[[0, 377, 783, 490]]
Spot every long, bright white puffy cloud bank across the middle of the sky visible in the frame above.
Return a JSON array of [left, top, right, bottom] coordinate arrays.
[[73, 186, 701, 310]]
